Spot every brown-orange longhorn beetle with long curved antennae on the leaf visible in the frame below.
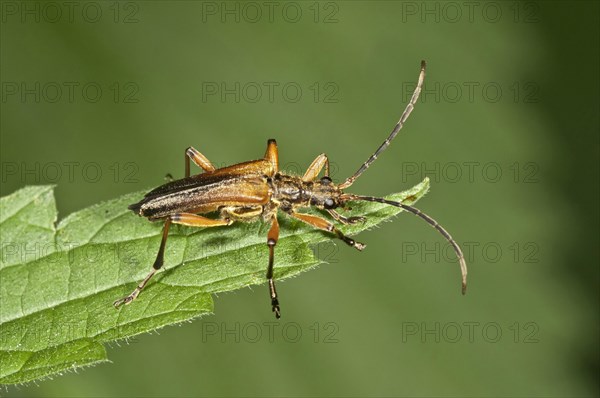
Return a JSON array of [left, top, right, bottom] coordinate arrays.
[[114, 61, 467, 318]]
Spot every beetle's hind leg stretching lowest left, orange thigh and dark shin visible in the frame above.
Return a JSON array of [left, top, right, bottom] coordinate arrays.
[[113, 213, 233, 308]]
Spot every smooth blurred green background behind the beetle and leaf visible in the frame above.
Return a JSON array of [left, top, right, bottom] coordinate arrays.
[[0, 1, 600, 397]]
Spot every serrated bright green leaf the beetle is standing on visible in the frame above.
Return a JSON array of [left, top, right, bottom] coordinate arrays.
[[0, 179, 429, 384]]
